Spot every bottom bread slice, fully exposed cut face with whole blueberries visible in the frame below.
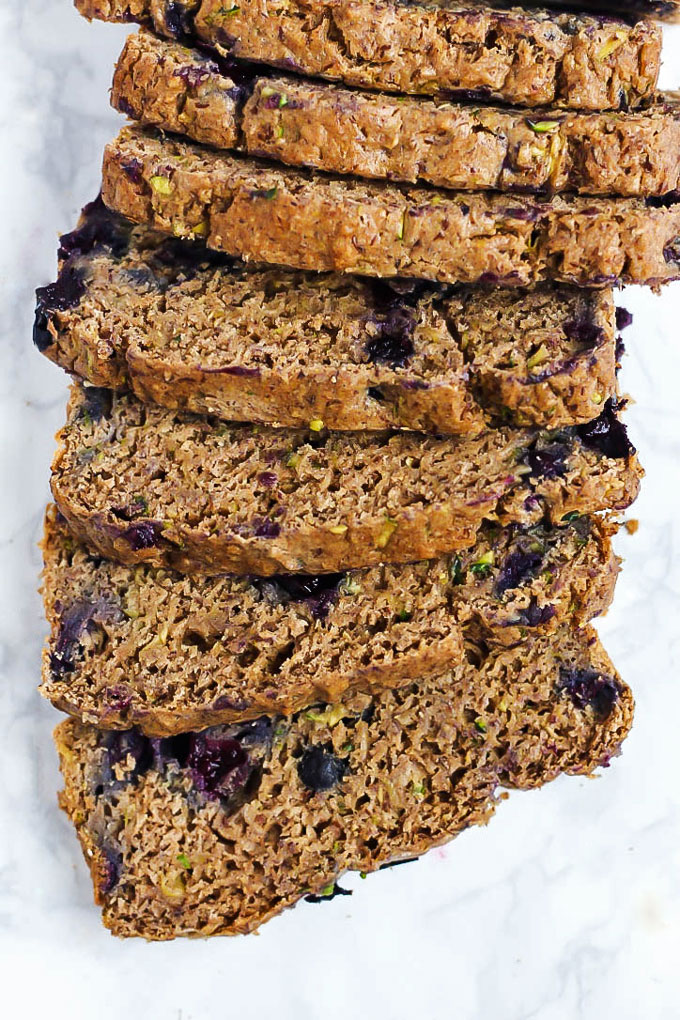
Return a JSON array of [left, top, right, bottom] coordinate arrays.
[[55, 630, 633, 939]]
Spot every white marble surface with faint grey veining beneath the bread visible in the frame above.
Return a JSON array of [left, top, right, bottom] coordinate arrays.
[[0, 0, 680, 1020]]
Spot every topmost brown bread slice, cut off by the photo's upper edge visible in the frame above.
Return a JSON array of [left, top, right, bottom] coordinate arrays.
[[75, 0, 661, 110]]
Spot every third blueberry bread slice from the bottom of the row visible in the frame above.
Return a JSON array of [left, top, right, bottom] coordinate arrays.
[[52, 386, 641, 575]]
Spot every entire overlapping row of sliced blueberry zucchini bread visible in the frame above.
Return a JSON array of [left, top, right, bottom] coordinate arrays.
[[35, 0, 680, 938]]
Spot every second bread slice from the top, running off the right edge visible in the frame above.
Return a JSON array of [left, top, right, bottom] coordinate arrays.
[[111, 32, 680, 196]]
